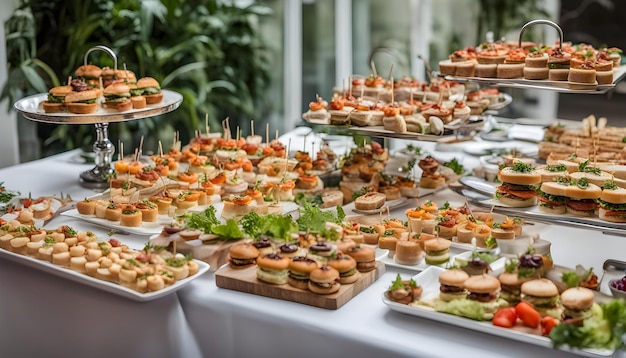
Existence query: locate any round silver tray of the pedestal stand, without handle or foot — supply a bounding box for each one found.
[14,90,183,124]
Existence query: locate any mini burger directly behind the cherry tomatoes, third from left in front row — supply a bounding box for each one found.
[521,278,563,319]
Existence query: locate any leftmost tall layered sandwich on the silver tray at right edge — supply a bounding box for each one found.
[495,161,541,208]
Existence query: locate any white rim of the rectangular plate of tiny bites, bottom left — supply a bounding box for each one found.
[0,249,210,302]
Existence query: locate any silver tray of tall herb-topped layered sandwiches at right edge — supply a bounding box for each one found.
[459,161,626,235]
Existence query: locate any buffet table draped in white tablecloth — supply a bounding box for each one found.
[0,133,626,358]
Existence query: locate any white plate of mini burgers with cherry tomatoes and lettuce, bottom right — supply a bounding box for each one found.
[382,267,625,357]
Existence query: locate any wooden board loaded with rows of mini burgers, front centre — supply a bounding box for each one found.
[215,243,385,309]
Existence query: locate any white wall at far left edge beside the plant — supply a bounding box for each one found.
[0,0,19,168]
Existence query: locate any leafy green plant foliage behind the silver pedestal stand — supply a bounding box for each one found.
[0,0,270,154]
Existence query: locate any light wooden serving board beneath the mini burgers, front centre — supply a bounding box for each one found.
[215,261,385,310]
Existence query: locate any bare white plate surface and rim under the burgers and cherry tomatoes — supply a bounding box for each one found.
[382,266,614,357]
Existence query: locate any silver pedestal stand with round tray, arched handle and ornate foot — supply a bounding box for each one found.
[14,45,183,189]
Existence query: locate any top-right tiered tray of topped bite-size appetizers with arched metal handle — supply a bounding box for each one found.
[439,20,626,94]
